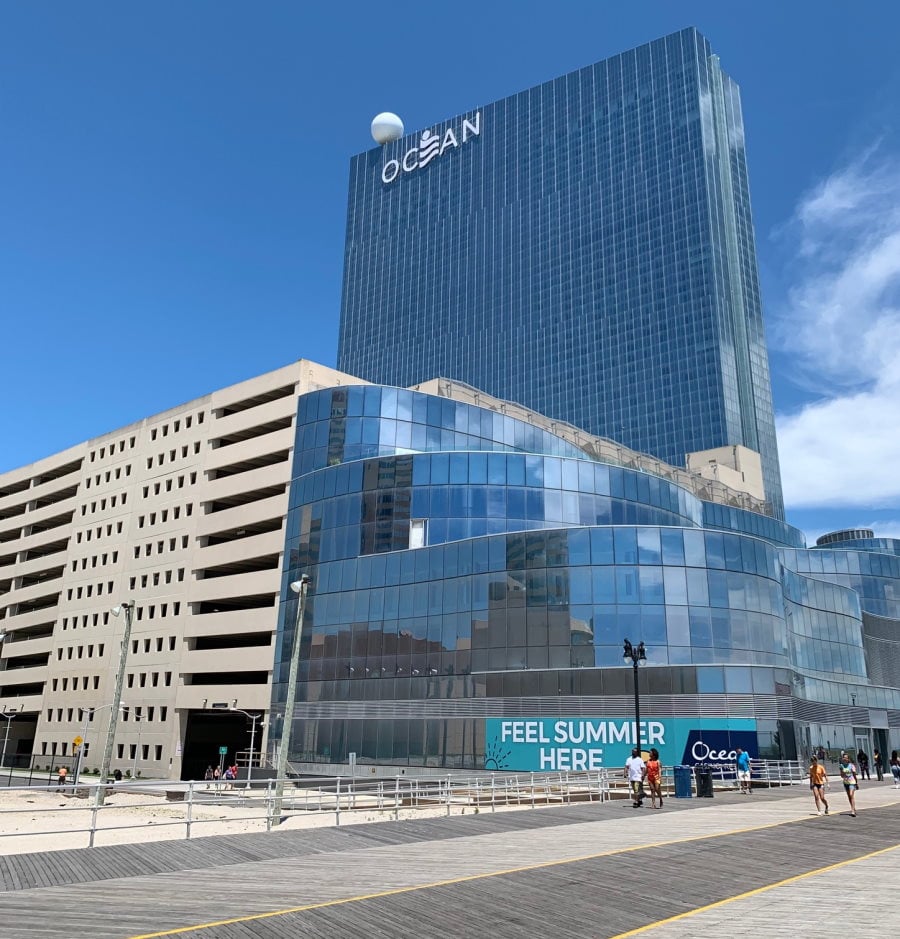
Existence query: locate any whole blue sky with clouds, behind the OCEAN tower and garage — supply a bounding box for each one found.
[0,0,900,537]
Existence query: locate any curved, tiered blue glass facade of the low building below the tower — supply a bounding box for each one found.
[273,386,900,768]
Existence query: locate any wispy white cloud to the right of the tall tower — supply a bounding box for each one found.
[776,151,900,510]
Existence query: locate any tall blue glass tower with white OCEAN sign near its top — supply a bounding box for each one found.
[338,28,783,518]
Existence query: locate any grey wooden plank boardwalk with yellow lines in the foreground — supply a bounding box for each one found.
[0,784,900,939]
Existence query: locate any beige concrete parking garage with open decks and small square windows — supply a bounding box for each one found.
[0,360,361,776]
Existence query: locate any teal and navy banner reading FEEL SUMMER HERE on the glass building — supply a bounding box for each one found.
[484,717,758,773]
